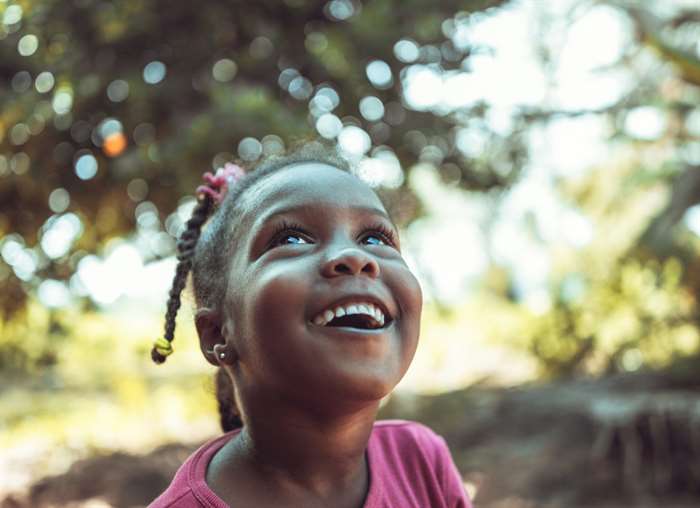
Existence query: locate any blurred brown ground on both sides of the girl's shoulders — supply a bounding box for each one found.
[5,373,700,508]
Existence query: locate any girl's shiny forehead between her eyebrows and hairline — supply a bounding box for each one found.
[241,162,384,220]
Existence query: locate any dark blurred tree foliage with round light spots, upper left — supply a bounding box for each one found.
[0,0,521,326]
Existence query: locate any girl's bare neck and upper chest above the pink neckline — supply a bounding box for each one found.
[207,401,379,507]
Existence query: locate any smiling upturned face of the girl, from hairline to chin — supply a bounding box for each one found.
[223,163,422,410]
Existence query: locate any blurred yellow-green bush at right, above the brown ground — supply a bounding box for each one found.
[529,258,700,376]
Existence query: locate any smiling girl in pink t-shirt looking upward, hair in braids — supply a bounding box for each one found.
[151,144,470,508]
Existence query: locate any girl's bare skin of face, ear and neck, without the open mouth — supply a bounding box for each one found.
[196,163,422,508]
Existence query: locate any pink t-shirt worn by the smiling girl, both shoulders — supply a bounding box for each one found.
[150,420,471,508]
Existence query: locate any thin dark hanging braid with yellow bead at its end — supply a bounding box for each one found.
[151,195,214,363]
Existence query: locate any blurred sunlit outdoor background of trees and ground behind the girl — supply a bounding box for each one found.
[0,0,700,508]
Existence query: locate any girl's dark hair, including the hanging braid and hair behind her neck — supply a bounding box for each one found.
[151,141,350,432]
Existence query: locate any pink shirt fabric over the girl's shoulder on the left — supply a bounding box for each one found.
[148,433,234,508]
